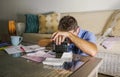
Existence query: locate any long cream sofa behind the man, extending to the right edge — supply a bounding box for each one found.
[17,10,120,76]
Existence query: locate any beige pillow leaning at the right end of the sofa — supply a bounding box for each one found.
[103,10,120,36]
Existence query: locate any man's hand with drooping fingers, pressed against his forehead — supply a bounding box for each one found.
[52,31,69,45]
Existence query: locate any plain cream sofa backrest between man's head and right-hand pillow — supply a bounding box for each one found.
[62,10,114,34]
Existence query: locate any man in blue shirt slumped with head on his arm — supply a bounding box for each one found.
[52,16,97,56]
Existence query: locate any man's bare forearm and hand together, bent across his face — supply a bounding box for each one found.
[52,32,97,56]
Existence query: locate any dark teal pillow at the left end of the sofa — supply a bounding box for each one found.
[25,14,39,33]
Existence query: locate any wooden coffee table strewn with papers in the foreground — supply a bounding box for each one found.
[0,51,102,77]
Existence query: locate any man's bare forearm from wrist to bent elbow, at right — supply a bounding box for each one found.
[68,32,97,56]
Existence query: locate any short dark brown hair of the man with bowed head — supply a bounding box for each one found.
[58,16,78,31]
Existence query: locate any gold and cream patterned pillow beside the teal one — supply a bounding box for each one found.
[39,12,60,34]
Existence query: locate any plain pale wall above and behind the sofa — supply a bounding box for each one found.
[0,0,120,41]
